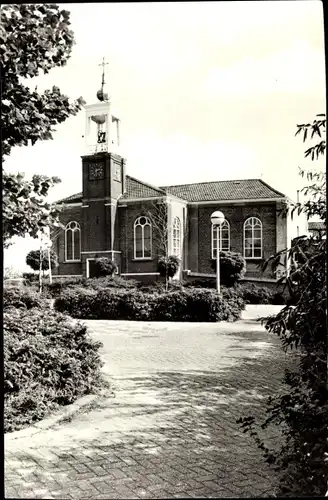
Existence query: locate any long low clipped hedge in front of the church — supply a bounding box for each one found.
[54,287,245,322]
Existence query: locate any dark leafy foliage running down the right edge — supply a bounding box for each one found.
[239,115,328,497]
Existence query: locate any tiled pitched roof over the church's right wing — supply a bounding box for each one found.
[162,179,285,202]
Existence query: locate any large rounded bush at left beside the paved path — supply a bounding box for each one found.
[3,309,103,432]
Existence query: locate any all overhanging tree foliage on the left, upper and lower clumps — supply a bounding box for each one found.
[0,4,84,246]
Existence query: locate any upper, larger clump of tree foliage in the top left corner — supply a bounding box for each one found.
[0,4,83,155]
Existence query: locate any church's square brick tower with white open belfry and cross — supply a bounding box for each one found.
[81,58,125,276]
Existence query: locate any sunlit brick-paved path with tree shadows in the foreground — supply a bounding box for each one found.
[5,306,292,500]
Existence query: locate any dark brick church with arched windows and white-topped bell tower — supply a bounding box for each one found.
[53,66,307,282]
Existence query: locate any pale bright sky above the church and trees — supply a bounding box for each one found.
[5,0,326,270]
